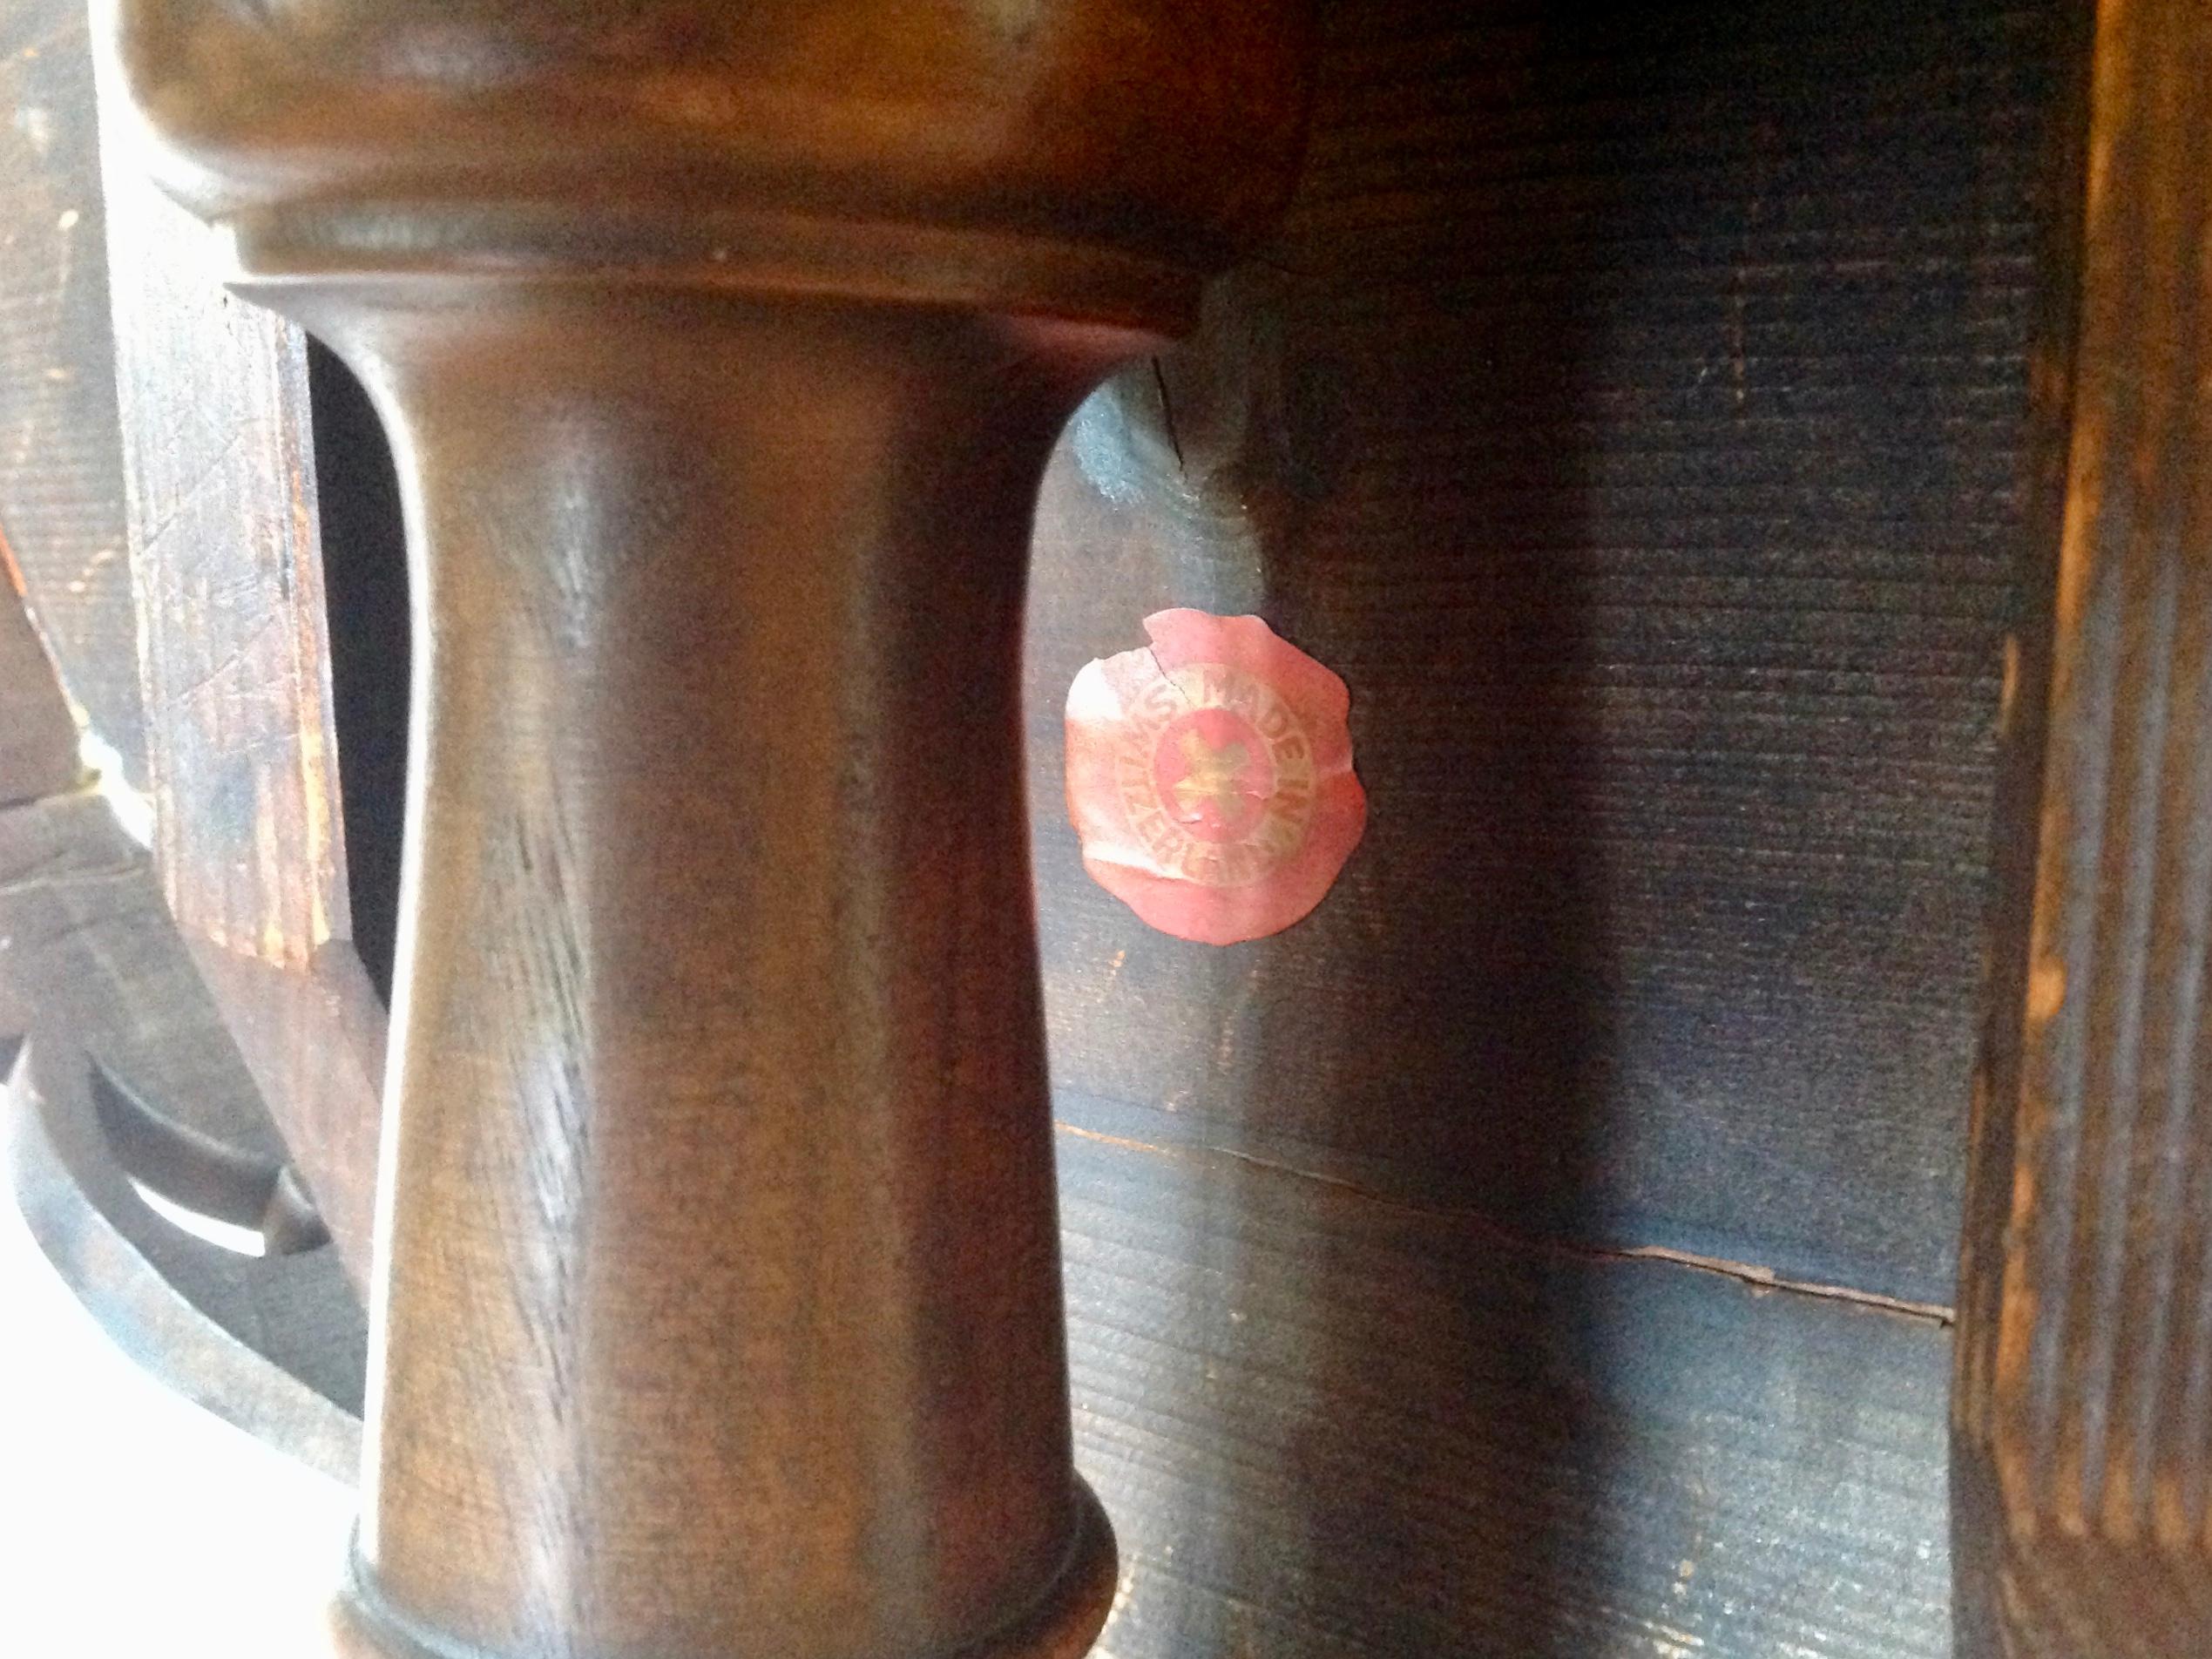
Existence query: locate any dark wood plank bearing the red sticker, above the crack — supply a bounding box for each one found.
[1029,0,2066,1303]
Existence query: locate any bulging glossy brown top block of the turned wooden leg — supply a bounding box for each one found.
[106,0,1308,331]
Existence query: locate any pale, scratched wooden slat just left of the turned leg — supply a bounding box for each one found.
[89,48,389,1281]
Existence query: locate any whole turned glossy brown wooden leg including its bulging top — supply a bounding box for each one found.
[102,0,1305,1659]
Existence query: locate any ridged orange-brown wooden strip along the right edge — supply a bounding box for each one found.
[1955,0,2212,1659]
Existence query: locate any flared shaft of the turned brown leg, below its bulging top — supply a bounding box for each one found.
[325,295,1120,1655]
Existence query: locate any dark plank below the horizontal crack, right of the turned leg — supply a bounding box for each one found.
[1059,1126,1951,1659]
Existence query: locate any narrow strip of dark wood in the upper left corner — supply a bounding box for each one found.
[0,0,146,788]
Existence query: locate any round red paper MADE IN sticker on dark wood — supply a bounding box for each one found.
[1068,611,1367,945]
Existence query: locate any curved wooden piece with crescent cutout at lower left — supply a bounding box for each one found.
[0,792,365,1469]
